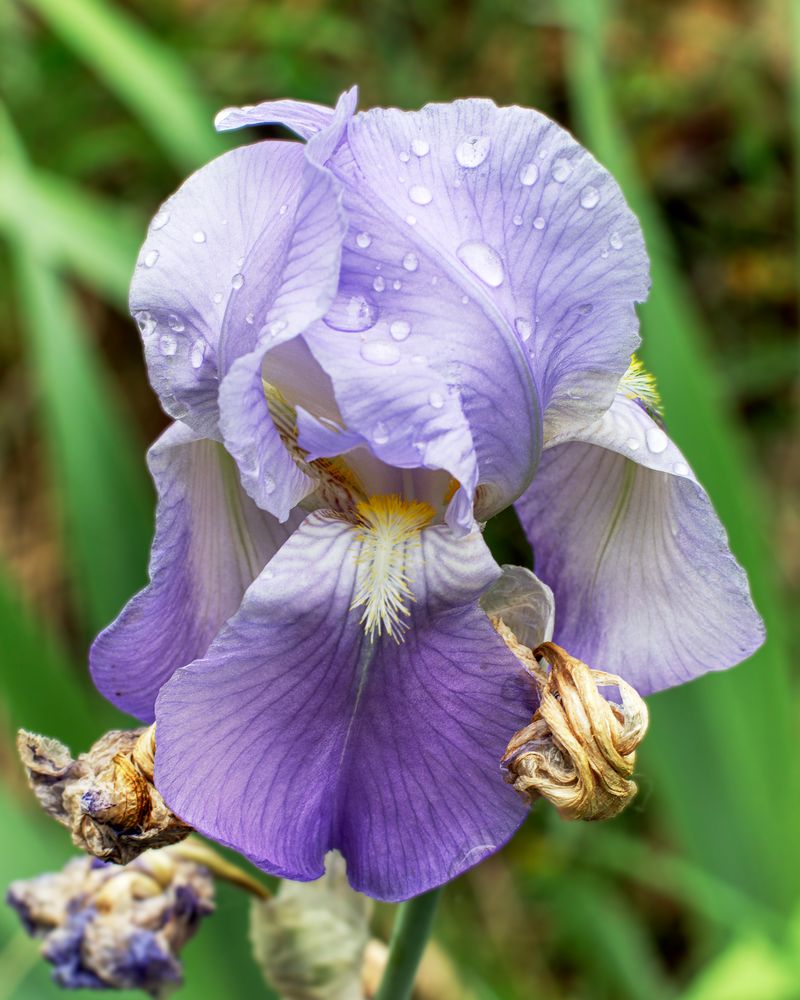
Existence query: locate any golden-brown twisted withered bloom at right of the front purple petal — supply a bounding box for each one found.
[495,640,648,820]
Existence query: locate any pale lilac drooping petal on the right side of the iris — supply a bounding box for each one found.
[517,395,764,694]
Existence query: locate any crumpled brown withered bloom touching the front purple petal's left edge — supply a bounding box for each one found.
[17,726,191,864]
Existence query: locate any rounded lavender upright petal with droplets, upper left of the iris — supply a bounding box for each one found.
[130,142,343,446]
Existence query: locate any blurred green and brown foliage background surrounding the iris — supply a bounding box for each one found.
[0,0,800,1000]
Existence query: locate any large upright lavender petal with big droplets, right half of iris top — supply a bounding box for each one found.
[296,100,648,516]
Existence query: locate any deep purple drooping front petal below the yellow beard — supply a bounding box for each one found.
[156,513,530,900]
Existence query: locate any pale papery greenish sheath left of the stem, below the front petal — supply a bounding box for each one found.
[250,855,371,1000]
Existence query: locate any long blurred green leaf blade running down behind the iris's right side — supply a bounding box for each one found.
[568,0,800,906]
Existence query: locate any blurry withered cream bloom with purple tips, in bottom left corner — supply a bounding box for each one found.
[7,848,214,997]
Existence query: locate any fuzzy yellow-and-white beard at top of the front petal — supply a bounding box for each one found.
[351,496,435,642]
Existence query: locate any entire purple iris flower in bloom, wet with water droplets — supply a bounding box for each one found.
[91,91,763,900]
